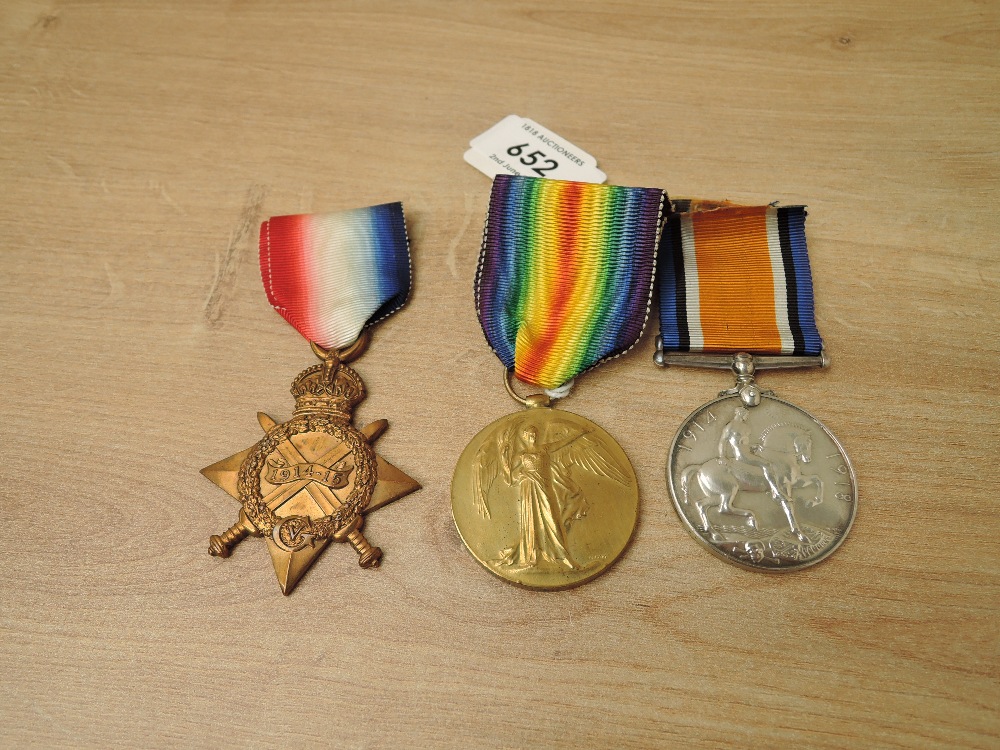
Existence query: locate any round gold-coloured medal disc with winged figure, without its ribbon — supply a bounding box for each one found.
[451,407,639,590]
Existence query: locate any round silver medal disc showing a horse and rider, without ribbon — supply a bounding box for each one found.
[667,395,858,571]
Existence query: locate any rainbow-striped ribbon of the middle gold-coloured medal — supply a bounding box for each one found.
[476,175,666,388]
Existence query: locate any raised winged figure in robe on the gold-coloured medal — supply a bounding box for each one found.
[473,418,628,570]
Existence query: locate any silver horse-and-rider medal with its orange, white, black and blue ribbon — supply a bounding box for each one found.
[656,206,857,571]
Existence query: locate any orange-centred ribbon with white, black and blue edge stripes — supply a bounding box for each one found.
[659,206,823,354]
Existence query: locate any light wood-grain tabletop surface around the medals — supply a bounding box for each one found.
[0,0,1000,748]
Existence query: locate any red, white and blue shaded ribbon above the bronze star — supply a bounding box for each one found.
[260,203,410,349]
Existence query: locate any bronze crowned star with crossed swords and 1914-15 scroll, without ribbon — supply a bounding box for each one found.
[202,331,420,594]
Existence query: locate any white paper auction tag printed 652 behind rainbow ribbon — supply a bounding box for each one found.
[465,115,607,183]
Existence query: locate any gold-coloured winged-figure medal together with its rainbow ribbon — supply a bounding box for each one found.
[451,175,665,590]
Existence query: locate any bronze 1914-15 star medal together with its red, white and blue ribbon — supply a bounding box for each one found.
[202,203,420,594]
